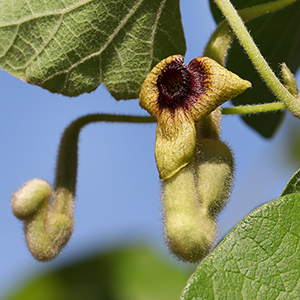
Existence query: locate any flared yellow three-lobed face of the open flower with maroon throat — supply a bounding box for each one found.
[139,55,251,179]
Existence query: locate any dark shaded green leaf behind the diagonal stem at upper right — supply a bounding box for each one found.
[210,0,300,138]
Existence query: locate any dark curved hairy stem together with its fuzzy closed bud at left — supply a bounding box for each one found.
[11,114,155,261]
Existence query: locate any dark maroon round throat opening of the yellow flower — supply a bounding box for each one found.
[157,62,191,110]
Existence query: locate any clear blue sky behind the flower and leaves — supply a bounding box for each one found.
[0,0,300,298]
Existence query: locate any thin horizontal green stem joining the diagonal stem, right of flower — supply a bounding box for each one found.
[222,102,286,115]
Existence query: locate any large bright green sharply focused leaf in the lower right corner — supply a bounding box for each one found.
[181,171,300,300]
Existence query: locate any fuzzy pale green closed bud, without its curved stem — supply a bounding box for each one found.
[11,179,74,261]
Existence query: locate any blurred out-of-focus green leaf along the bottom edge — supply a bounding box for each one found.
[6,246,190,300]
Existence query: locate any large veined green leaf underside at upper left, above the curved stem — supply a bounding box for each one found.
[0,0,185,99]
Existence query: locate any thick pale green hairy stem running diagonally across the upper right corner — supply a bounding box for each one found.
[215,0,300,118]
